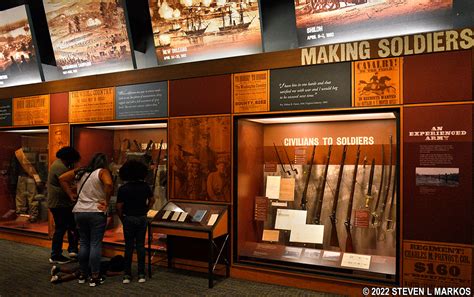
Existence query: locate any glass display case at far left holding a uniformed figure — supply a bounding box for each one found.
[0,128,48,234]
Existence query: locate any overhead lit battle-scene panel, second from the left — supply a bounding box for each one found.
[43,0,133,78]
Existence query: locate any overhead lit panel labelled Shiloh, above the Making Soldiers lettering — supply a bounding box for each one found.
[295,0,460,47]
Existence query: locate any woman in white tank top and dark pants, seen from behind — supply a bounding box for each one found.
[59,153,113,287]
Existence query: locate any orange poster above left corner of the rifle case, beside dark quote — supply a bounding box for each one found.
[232,71,270,113]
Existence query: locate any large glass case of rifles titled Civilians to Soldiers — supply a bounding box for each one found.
[234,109,399,283]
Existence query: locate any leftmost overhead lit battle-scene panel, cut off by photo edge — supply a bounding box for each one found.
[0,5,41,88]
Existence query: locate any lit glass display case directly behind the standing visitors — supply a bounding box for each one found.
[72,122,168,249]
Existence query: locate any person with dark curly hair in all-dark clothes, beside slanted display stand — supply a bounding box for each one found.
[117,160,155,284]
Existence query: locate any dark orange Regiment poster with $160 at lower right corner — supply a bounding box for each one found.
[403,240,473,288]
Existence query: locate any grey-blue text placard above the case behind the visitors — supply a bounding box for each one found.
[115,81,168,120]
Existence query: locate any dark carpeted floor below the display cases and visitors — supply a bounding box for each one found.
[0,240,342,297]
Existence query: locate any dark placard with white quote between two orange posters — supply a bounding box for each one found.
[270,63,351,111]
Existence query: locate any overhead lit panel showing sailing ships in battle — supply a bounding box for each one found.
[148,0,262,65]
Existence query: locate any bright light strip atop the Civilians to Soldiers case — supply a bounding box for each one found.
[249,112,396,124]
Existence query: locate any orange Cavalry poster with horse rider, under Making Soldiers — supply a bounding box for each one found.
[352,58,403,106]
